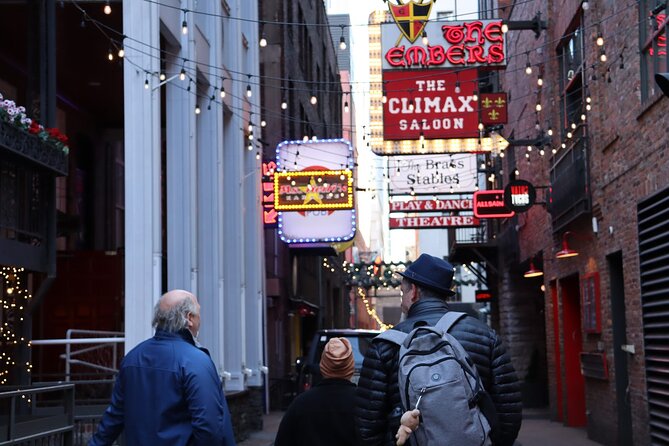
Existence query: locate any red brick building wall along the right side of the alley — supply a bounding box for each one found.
[498,0,669,445]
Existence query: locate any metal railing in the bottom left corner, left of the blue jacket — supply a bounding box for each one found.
[0,384,74,446]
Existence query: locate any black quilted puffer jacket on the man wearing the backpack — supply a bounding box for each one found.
[355,297,522,446]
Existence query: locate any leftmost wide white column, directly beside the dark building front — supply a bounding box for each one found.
[123,0,162,352]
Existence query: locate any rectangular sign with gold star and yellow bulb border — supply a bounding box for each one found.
[274,169,353,211]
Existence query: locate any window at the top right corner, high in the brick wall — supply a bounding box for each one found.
[639,0,668,102]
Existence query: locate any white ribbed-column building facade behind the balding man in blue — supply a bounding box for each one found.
[123,0,266,391]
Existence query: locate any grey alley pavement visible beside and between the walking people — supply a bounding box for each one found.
[238,409,599,446]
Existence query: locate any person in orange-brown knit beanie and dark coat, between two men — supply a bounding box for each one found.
[274,338,358,446]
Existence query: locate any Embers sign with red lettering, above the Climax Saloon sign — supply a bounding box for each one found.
[381,19,506,69]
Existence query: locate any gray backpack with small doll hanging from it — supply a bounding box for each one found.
[376,311,496,446]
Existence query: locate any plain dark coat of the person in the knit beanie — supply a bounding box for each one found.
[274,378,356,446]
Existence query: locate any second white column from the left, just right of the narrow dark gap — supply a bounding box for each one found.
[165,3,199,298]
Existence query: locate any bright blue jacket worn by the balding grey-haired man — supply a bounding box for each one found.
[88,330,235,446]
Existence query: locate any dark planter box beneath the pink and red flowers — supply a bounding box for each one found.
[0,121,68,176]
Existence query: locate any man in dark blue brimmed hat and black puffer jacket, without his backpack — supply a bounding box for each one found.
[355,254,522,446]
